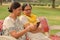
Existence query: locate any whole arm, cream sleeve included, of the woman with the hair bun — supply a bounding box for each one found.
[3,20,30,38]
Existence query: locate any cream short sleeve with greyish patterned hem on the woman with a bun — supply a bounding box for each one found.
[3,20,16,34]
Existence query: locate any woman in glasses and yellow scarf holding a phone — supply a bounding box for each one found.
[19,3,50,40]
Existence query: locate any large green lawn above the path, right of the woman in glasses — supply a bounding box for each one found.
[32,7,60,25]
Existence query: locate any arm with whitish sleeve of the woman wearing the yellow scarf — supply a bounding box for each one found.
[20,16,37,32]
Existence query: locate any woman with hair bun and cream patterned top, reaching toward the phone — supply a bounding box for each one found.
[3,2,35,40]
